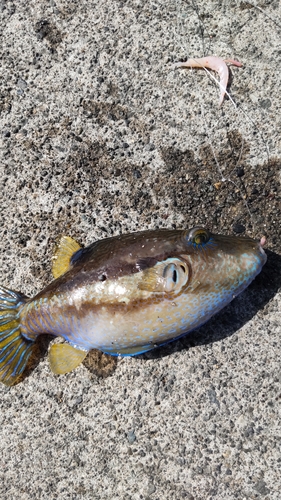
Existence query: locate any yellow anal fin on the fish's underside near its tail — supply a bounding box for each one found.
[49,344,88,375]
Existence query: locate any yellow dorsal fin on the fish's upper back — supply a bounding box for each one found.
[52,235,81,278]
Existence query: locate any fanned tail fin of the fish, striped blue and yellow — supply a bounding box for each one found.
[0,286,34,386]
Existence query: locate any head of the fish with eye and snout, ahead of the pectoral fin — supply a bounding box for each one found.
[174,227,267,310]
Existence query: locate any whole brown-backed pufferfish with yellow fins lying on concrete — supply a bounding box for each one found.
[0,227,266,385]
